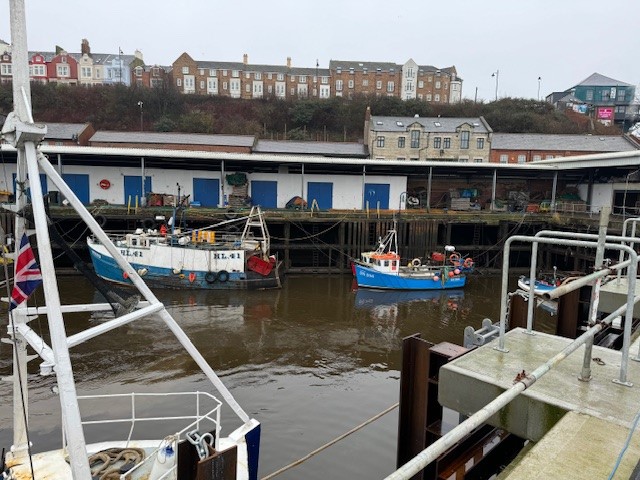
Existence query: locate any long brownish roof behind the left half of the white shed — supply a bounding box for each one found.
[89,131,255,148]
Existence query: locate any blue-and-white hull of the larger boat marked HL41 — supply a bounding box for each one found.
[88,240,281,290]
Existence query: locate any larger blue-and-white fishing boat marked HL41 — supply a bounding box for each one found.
[87,207,281,290]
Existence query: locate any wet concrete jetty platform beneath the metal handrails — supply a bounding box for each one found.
[438,328,640,479]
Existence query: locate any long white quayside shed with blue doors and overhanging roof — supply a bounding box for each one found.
[0,128,640,213]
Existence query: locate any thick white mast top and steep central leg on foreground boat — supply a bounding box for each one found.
[3,0,91,479]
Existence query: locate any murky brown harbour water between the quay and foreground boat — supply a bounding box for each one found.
[0,275,540,480]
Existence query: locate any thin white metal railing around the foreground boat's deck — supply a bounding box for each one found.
[62,391,222,456]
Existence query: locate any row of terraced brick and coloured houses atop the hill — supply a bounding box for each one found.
[0,39,462,104]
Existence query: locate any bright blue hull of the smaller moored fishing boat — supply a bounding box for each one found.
[354,263,467,290]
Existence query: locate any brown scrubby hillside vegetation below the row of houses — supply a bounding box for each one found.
[0,83,621,141]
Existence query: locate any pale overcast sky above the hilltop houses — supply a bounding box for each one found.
[0,0,640,101]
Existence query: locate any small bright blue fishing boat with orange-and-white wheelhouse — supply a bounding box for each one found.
[353,229,473,290]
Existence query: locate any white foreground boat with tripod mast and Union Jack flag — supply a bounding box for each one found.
[0,0,261,480]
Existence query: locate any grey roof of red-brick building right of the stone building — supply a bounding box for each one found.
[491,133,638,153]
